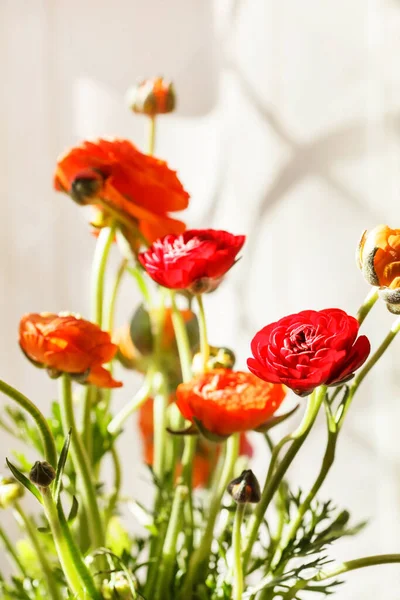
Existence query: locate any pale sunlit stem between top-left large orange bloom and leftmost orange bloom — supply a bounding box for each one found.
[91,224,115,327]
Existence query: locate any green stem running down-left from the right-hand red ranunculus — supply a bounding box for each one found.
[243,386,326,573]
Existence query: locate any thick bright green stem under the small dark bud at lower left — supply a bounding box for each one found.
[42,488,101,600]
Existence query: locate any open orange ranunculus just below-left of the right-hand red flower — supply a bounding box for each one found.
[176,369,285,437]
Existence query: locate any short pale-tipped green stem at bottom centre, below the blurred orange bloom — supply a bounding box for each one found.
[154,485,188,600]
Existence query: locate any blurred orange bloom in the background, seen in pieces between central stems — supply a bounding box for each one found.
[139,398,253,488]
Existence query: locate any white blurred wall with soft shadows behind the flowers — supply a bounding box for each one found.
[0,0,400,600]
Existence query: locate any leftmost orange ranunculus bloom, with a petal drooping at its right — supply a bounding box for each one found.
[19,313,122,388]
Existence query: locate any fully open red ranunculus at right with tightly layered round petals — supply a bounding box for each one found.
[247,308,370,396]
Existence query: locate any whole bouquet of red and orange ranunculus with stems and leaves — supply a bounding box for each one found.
[0,78,400,600]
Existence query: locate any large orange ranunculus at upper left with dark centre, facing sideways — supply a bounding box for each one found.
[54,139,189,243]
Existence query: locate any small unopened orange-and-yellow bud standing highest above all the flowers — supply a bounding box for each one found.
[127,77,176,117]
